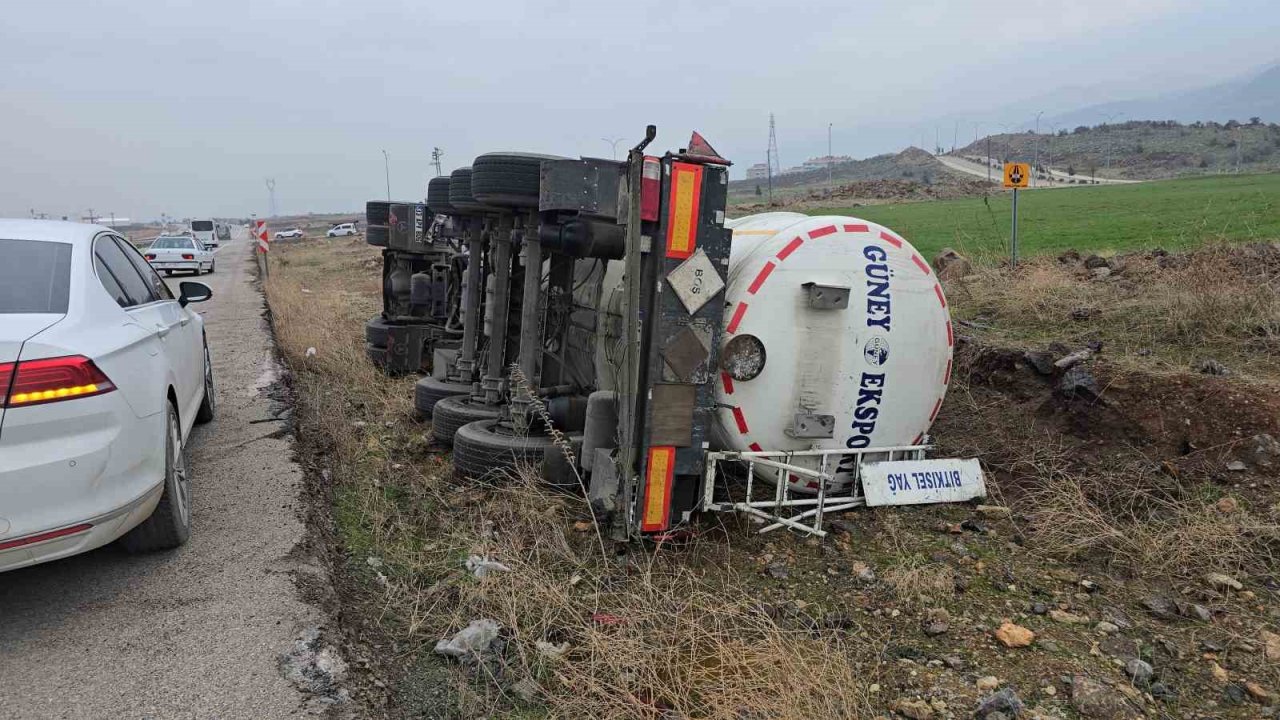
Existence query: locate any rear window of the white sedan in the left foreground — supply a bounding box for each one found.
[0,238,72,314]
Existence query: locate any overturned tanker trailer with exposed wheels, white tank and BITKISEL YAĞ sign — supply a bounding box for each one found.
[370,127,984,538]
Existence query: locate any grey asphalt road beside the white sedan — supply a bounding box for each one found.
[0,229,321,720]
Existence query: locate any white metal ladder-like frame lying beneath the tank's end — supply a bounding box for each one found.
[699,445,932,537]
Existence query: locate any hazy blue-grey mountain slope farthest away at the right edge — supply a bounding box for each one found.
[1048,64,1280,127]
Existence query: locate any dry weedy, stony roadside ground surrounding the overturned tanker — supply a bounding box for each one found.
[268,233,1280,719]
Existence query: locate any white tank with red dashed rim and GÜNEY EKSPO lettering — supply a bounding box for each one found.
[596,213,954,492]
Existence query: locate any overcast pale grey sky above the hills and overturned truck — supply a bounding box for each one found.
[0,0,1280,218]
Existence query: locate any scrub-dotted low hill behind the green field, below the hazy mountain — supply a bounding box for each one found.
[955,117,1280,179]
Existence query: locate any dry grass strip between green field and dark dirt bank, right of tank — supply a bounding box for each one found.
[948,243,1280,379]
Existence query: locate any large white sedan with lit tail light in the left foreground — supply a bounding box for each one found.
[0,220,214,571]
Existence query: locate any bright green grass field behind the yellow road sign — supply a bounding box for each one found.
[809,173,1280,259]
